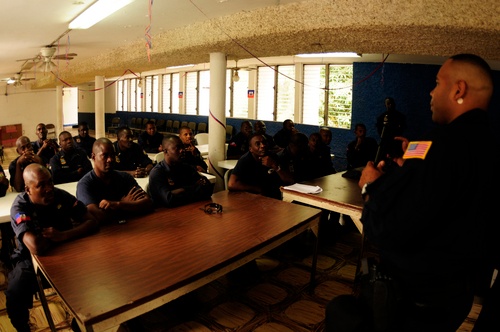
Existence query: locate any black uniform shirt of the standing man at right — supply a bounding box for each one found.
[361,110,499,303]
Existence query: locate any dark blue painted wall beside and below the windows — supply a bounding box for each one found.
[83,62,500,171]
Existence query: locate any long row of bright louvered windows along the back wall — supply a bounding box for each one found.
[117,64,353,129]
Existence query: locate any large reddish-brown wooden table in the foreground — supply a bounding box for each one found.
[33,191,321,331]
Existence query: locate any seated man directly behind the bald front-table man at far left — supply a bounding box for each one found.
[9,136,45,192]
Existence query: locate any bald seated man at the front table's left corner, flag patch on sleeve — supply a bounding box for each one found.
[5,164,98,331]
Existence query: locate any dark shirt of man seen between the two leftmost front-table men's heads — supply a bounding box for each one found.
[50,148,92,184]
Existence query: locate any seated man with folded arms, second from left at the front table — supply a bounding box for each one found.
[76,138,153,223]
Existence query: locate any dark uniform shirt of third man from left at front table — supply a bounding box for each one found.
[148,160,213,207]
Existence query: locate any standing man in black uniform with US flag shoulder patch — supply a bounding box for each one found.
[346,54,500,332]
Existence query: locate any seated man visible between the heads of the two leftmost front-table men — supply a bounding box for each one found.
[50,131,92,184]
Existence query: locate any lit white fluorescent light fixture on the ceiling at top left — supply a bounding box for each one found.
[68,0,134,30]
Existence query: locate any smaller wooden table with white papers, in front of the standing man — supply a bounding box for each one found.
[281,172,364,233]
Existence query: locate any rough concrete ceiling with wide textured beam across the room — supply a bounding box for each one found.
[0,0,500,88]
